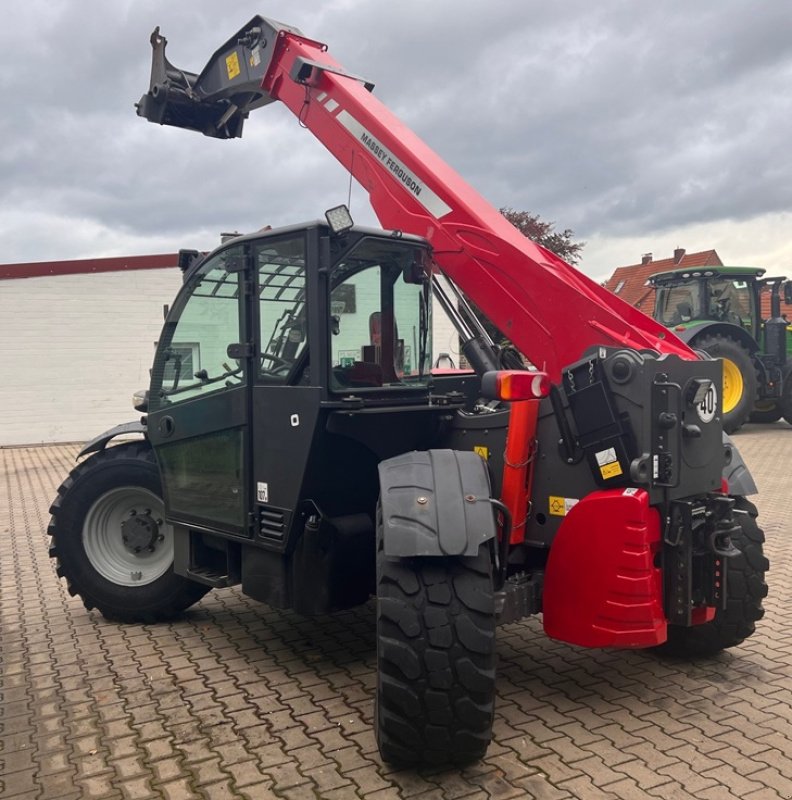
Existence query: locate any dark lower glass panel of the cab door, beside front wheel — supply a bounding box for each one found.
[158,428,245,529]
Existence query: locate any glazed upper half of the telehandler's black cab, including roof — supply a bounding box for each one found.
[149,222,431,411]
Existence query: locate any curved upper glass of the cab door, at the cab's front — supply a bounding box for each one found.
[150,247,244,411]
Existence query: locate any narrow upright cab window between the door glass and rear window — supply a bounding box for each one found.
[256,236,308,383]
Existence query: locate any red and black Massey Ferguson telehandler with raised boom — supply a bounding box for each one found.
[49,16,768,764]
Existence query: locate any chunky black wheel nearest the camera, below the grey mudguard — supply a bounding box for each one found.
[376,510,495,766]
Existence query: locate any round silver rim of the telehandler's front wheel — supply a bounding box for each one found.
[82,486,173,586]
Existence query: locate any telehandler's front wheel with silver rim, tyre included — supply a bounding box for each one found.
[48,442,209,622]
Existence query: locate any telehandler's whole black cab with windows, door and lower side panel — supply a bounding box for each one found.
[140,221,441,549]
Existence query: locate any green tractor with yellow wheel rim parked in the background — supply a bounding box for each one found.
[649,267,792,433]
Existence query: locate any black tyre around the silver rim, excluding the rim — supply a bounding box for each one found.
[47,440,209,623]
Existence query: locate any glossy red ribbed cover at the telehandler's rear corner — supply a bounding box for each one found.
[542,489,667,647]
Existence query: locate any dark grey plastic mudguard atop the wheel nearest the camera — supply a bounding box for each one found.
[379,450,496,558]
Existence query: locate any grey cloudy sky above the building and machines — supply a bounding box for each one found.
[0,0,792,278]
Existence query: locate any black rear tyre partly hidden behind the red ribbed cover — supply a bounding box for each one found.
[656,497,770,658]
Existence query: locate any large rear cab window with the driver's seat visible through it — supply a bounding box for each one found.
[329,237,431,391]
